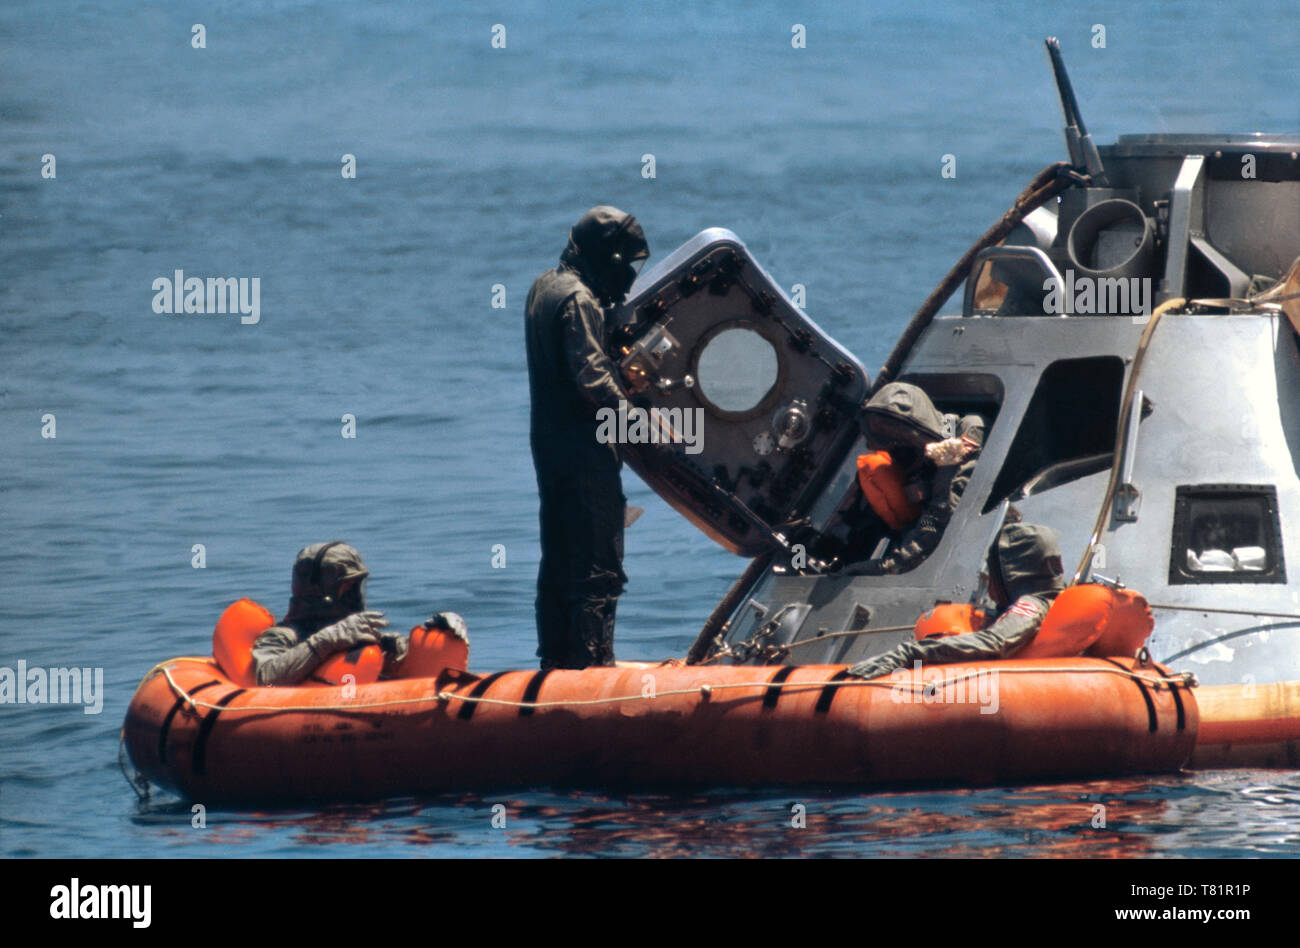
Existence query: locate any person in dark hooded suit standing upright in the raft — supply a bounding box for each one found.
[525,204,650,668]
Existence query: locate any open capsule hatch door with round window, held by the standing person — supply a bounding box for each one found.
[606,228,868,557]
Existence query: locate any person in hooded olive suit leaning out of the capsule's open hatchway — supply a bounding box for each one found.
[844,382,985,576]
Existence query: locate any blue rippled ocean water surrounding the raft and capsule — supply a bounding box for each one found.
[0,0,1300,857]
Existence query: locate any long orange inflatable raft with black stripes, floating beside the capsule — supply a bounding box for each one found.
[124,603,1201,802]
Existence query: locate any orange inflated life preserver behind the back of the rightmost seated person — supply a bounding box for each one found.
[1015,583,1154,658]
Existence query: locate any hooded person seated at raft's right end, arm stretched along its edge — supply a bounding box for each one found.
[849,523,1065,679]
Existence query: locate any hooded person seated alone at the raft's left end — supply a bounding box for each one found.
[252,540,468,685]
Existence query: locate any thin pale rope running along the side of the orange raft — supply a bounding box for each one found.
[146,658,1197,714]
